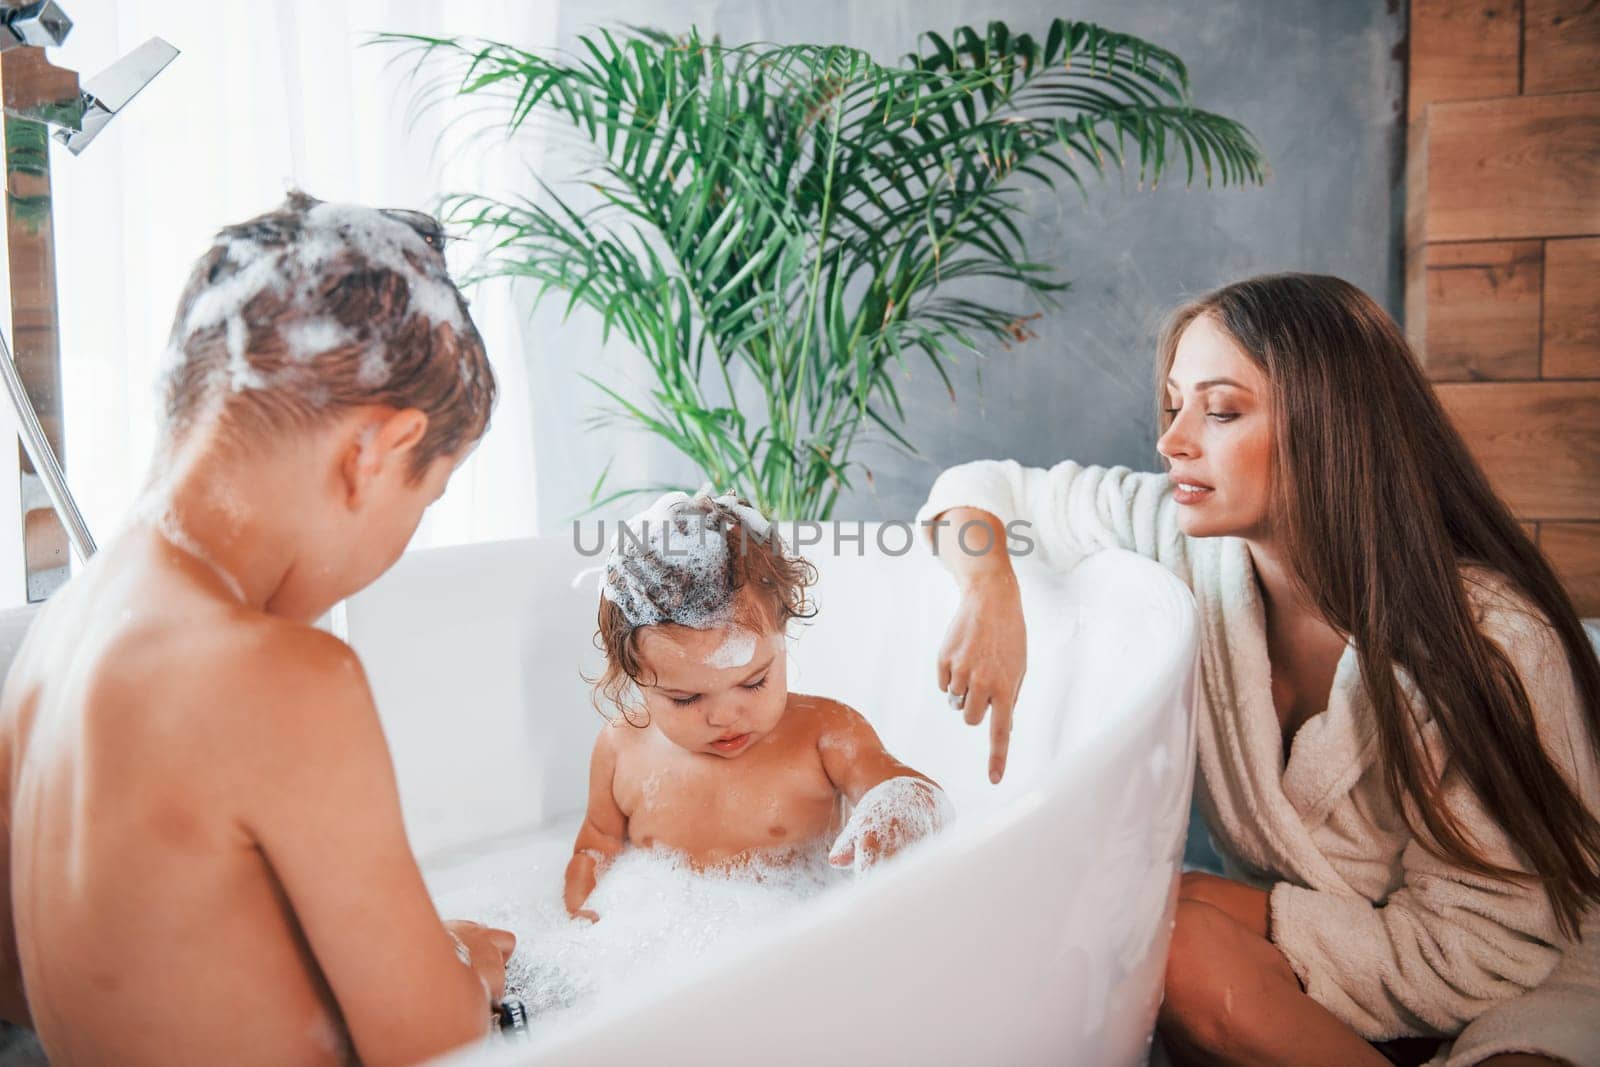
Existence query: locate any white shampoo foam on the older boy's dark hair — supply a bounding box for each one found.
[183,203,475,392]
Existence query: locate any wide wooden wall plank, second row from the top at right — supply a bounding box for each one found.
[1406,93,1600,242]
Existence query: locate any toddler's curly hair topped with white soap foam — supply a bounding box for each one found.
[595,490,816,721]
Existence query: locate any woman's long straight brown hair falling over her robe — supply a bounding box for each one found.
[1157,274,1600,936]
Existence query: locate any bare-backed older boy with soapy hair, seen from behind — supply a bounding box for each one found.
[0,194,514,1067]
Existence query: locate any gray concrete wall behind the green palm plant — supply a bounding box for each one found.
[538,0,1405,528]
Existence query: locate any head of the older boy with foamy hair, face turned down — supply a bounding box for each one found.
[165,192,494,613]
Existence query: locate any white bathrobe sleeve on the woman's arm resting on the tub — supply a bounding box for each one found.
[917,459,1189,582]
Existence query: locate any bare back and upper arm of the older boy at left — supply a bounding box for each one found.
[0,531,486,1064]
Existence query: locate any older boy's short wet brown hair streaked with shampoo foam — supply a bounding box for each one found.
[165,192,494,480]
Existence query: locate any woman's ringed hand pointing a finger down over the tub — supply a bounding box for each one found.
[939,566,1027,782]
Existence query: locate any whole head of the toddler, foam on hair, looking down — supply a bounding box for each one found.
[597,493,816,758]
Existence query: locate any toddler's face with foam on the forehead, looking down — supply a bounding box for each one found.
[638,607,789,760]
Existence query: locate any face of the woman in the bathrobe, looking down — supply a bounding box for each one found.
[1155,315,1272,541]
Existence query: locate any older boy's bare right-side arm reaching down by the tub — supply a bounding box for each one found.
[236,627,515,1064]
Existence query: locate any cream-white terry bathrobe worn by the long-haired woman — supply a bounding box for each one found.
[917,461,1600,1067]
